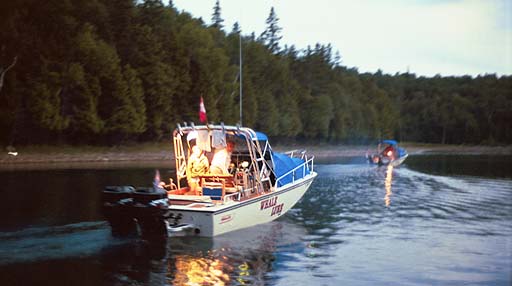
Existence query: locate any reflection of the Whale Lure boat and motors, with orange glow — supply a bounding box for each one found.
[98,222,303,285]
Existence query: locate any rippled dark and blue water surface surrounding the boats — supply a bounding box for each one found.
[0,155,512,286]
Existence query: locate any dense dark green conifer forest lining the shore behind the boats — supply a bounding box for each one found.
[0,0,512,146]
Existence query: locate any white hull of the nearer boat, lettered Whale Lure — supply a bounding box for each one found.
[167,172,317,237]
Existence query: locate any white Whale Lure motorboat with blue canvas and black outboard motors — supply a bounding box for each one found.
[103,125,317,237]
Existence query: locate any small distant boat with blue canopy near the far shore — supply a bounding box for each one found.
[366,139,409,167]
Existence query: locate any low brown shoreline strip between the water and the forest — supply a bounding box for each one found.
[0,142,512,166]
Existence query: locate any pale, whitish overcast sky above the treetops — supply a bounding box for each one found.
[173,0,512,77]
